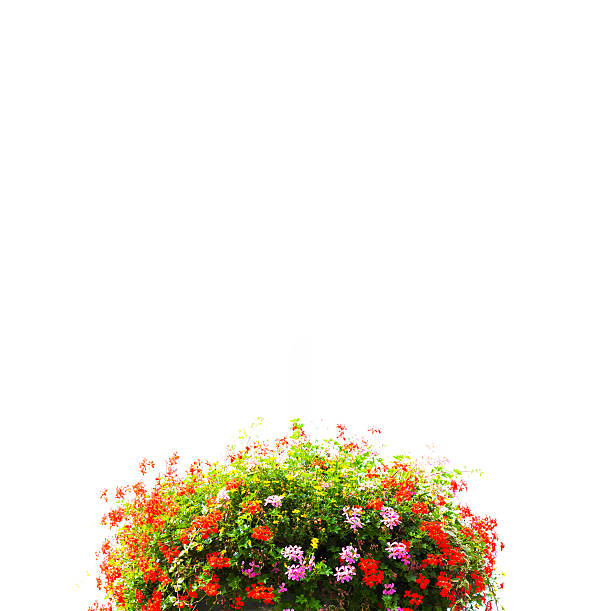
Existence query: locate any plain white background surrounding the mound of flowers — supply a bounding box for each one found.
[0,0,612,611]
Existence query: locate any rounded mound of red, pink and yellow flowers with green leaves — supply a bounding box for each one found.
[89,420,503,611]
